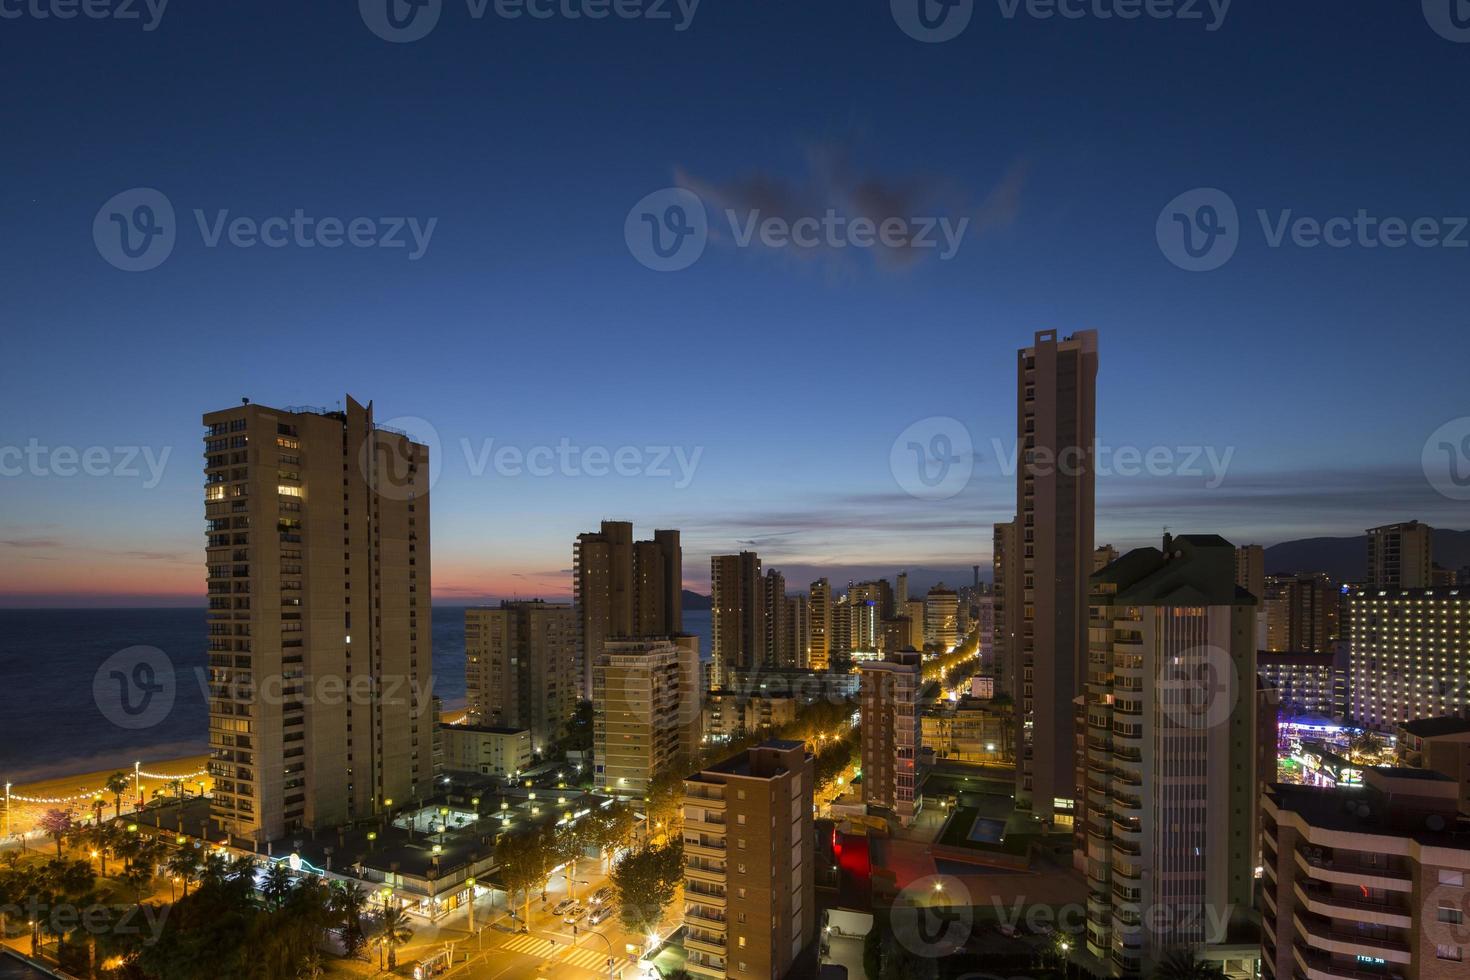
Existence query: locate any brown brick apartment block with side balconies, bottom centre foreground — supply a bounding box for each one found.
[684,741,817,980]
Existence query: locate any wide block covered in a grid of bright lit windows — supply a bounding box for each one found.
[1348,589,1470,732]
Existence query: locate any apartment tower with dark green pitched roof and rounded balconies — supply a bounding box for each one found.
[1079,535,1258,977]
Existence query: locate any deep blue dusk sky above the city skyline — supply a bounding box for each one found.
[0,0,1470,602]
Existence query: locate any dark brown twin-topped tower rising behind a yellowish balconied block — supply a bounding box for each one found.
[572,520,684,696]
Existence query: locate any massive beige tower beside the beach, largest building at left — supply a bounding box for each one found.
[204,398,434,843]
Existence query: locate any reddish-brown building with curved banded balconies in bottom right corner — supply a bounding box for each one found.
[1260,768,1470,980]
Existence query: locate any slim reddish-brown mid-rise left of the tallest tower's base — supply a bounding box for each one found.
[858,651,923,827]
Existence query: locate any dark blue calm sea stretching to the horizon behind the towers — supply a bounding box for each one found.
[0,605,710,783]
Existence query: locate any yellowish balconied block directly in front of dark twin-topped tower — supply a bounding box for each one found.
[592,636,704,798]
